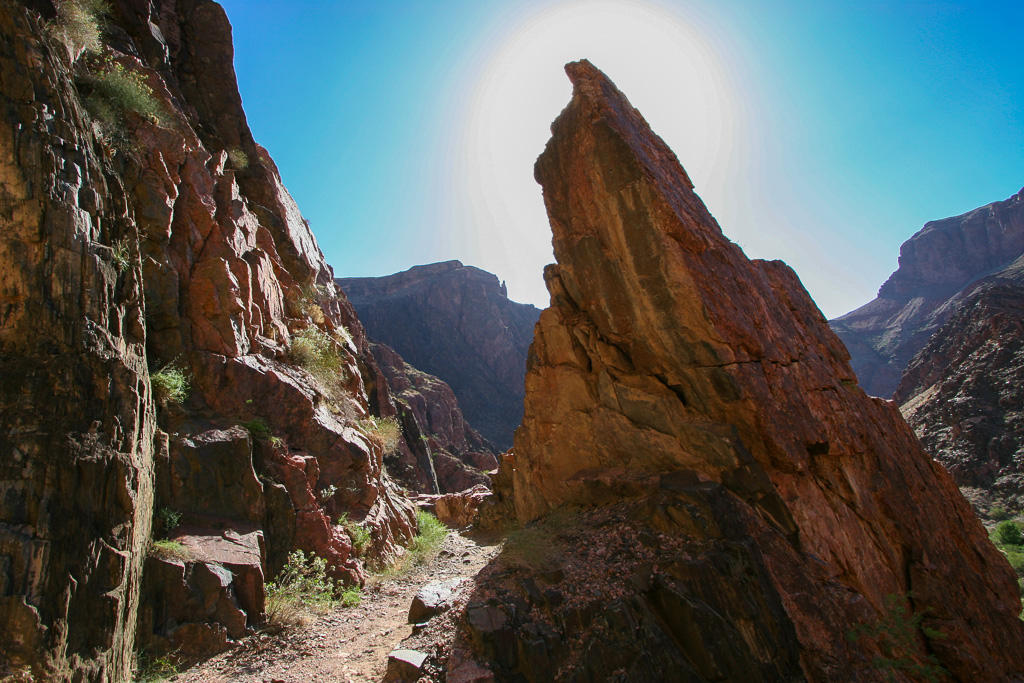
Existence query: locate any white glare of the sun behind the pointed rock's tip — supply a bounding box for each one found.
[450,0,742,304]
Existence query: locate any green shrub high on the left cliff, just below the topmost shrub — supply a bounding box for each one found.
[77,57,166,125]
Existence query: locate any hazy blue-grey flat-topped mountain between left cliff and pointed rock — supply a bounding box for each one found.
[337,261,540,449]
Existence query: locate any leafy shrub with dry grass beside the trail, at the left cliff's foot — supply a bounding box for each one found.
[266,550,359,632]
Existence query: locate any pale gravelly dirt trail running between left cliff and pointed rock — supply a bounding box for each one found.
[167,531,499,683]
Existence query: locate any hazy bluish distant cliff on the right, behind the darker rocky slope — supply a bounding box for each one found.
[829,190,1024,398]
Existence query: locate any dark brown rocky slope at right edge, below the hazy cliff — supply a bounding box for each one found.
[894,285,1024,509]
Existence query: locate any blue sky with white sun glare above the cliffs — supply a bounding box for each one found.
[222,0,1024,317]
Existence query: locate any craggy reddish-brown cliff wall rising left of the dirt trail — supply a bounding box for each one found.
[0,0,415,681]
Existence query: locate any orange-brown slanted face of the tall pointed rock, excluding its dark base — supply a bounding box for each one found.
[512,61,1024,681]
